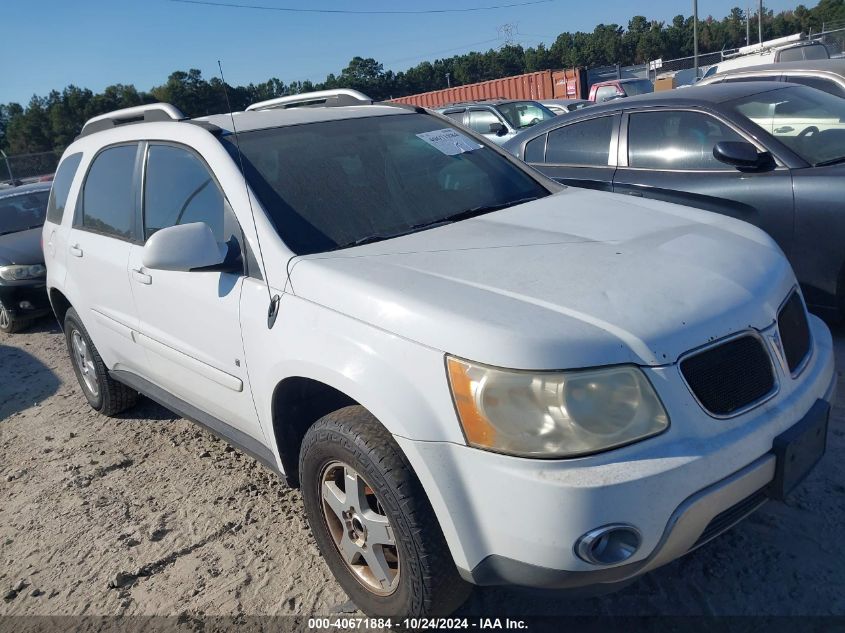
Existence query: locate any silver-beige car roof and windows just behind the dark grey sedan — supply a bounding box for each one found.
[697,59,845,97]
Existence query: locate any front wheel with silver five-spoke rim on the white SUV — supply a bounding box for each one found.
[299,406,471,618]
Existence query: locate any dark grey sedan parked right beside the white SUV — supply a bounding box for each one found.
[505,82,845,314]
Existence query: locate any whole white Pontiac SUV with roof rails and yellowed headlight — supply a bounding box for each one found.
[43,92,834,617]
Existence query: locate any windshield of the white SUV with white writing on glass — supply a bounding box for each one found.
[222,113,549,255]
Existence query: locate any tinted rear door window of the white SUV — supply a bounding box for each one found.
[82,145,137,239]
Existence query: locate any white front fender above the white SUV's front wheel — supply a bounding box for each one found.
[241,280,464,458]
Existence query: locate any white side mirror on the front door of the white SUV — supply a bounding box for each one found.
[141,222,229,271]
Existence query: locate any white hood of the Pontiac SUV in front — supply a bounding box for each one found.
[290,188,795,369]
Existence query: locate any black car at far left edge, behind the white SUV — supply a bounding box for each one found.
[0,183,50,333]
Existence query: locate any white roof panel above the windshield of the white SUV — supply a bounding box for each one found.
[192,104,414,133]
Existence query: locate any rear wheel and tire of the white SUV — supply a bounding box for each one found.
[65,308,138,416]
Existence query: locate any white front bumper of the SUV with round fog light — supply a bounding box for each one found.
[397,318,836,587]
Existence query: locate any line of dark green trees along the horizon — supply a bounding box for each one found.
[0,0,845,155]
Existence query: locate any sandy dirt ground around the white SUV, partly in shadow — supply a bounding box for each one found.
[0,319,845,617]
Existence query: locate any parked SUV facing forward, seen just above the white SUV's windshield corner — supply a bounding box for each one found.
[436,99,555,145]
